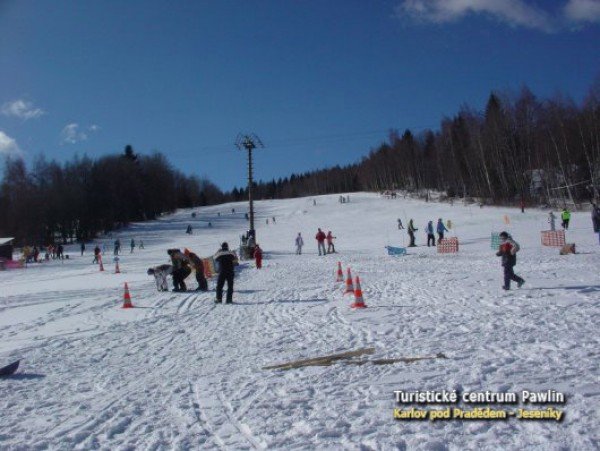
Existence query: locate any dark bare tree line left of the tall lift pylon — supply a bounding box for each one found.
[0,146,224,245]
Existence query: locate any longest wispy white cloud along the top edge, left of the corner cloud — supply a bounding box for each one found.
[396,0,556,32]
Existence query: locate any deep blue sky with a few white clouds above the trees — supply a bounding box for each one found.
[0,0,600,189]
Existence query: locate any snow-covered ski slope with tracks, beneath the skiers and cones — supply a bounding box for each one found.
[0,193,600,450]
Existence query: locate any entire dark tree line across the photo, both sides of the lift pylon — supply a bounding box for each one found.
[0,78,600,244]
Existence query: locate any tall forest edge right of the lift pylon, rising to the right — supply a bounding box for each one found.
[227,78,600,205]
